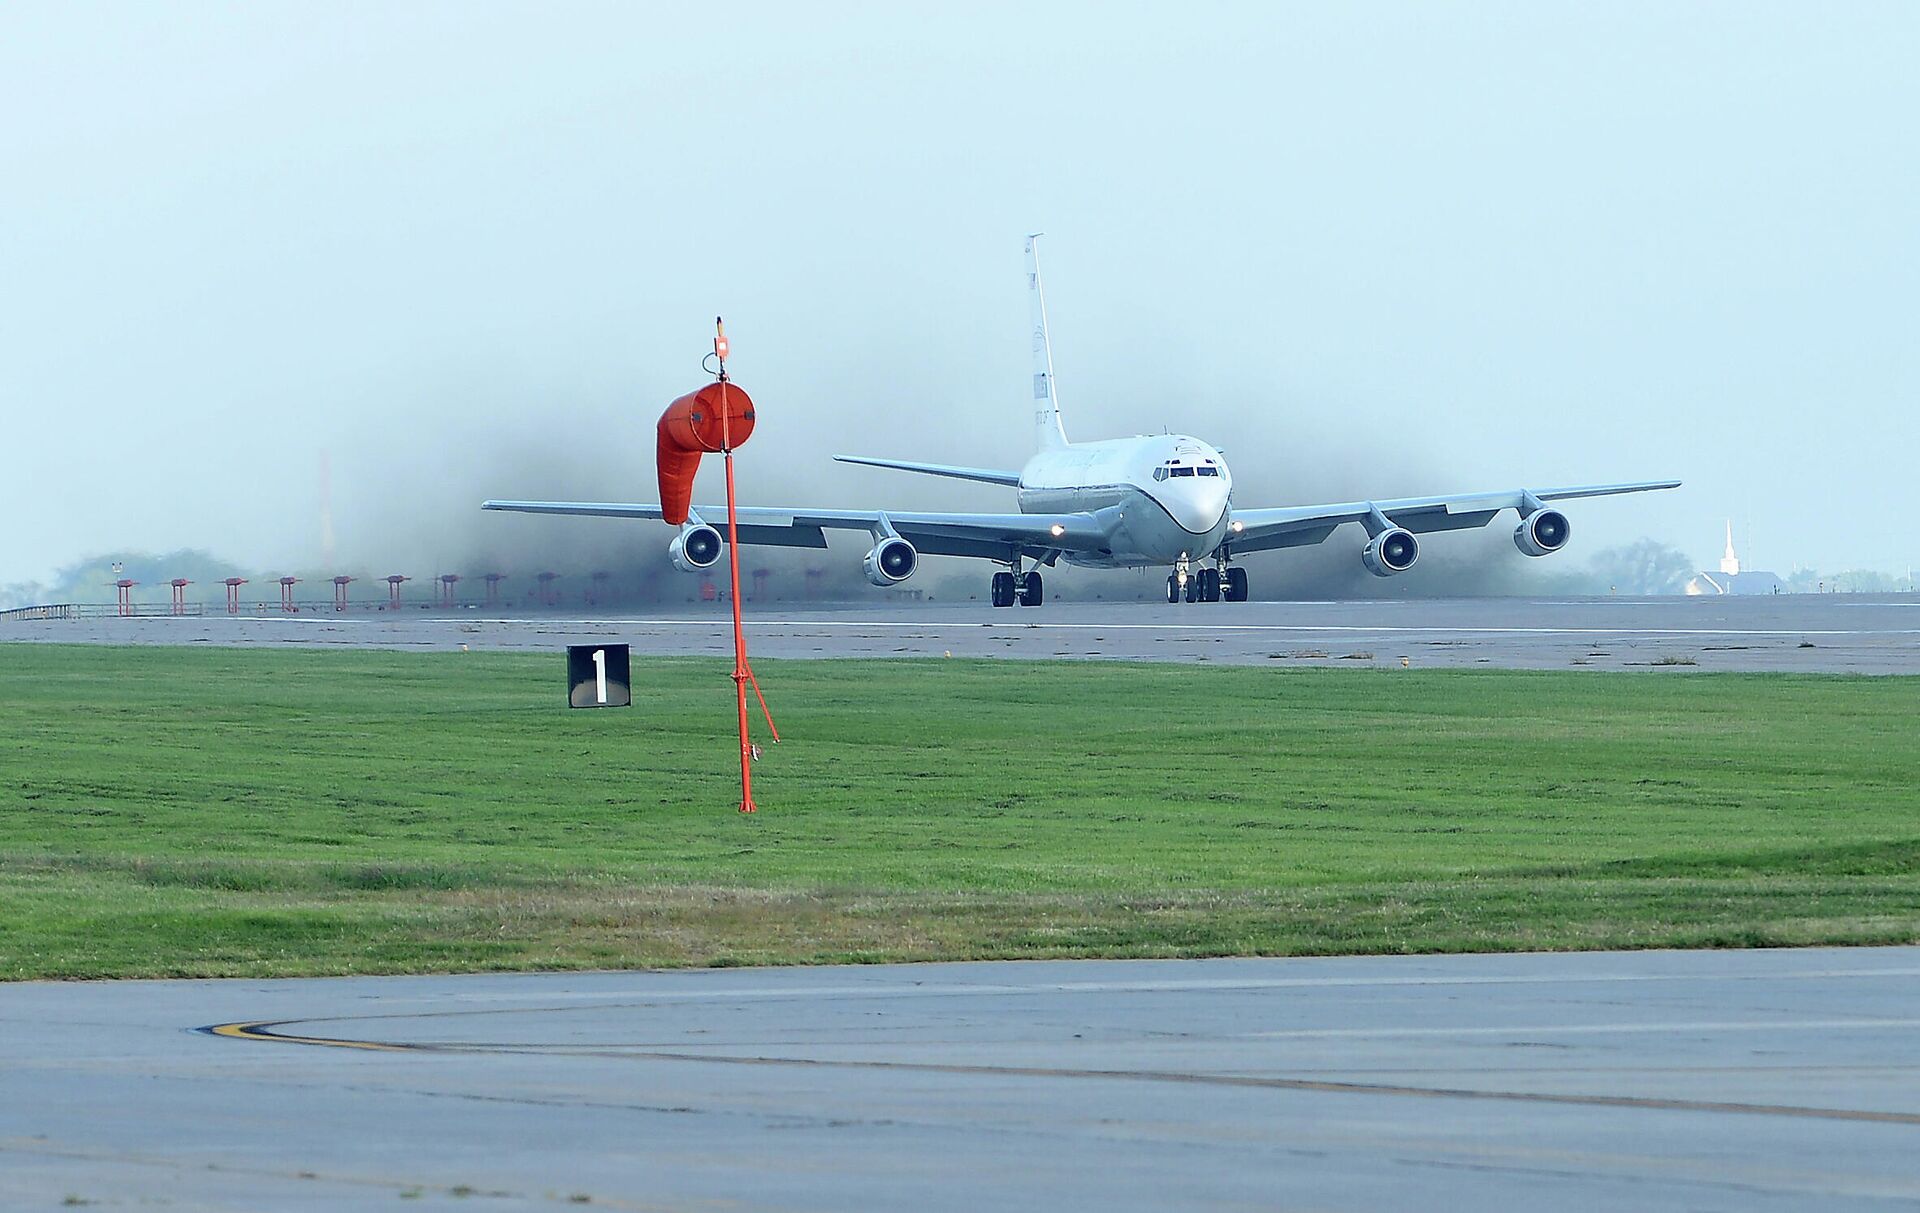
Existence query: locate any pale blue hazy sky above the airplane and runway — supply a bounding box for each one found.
[0,0,1920,582]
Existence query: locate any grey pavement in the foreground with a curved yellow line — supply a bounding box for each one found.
[0,948,1920,1211]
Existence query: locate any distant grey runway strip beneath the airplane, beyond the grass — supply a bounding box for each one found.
[0,595,1920,674]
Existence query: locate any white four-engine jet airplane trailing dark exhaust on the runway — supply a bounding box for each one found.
[482,236,1680,607]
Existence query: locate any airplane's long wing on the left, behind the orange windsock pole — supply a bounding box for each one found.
[480,501,1108,562]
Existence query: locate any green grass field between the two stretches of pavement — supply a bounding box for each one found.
[0,645,1920,979]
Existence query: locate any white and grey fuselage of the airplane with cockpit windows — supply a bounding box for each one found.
[1020,434,1233,568]
